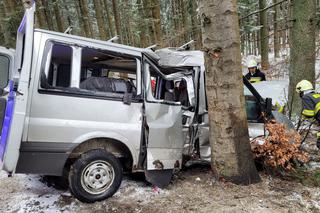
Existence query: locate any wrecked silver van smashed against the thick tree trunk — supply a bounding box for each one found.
[0,5,271,202]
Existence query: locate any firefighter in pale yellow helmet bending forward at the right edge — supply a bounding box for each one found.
[296,80,320,149]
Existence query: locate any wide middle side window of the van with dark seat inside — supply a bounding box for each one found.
[80,48,137,97]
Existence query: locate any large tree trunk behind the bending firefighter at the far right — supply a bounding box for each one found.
[289,0,316,114]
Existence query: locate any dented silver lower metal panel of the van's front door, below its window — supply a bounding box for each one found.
[145,102,184,170]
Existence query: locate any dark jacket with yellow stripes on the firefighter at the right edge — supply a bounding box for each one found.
[302,92,320,121]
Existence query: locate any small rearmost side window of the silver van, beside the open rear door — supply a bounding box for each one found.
[47,44,72,88]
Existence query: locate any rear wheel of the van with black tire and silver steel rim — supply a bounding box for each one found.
[69,149,122,203]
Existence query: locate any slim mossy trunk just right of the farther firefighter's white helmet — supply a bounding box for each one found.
[259,0,269,69]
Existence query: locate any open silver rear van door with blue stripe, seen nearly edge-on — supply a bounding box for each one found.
[0,4,35,173]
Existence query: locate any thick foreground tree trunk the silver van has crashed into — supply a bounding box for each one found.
[199,0,260,184]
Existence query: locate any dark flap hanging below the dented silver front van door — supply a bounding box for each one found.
[144,169,173,188]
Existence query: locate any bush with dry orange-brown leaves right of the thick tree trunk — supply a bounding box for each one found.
[251,120,309,171]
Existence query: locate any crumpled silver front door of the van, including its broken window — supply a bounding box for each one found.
[143,58,184,187]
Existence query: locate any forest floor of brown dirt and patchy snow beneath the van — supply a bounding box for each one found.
[0,136,320,213]
